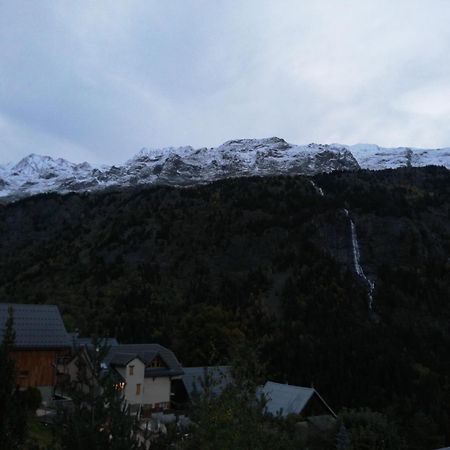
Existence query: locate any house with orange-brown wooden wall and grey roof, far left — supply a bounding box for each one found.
[0,303,71,401]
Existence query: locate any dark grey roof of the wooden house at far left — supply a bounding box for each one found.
[0,303,71,349]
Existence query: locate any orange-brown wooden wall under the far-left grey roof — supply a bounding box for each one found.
[11,349,69,387]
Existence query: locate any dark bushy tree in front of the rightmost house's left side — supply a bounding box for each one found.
[157,345,310,450]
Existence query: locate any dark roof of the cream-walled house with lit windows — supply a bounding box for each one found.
[103,344,184,378]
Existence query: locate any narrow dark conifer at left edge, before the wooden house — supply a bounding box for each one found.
[0,307,27,450]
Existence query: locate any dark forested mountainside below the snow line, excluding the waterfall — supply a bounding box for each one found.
[0,167,450,450]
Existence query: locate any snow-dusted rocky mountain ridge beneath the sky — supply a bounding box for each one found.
[0,137,450,200]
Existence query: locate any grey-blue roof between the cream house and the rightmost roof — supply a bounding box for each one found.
[182,366,232,397]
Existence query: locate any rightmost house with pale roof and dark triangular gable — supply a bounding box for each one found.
[260,381,337,418]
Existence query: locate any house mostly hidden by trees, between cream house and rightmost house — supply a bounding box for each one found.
[173,366,232,405]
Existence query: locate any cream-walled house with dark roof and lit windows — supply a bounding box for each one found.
[103,344,184,412]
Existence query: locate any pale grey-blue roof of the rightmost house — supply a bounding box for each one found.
[260,381,335,416]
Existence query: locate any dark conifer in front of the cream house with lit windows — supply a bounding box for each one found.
[58,342,146,450]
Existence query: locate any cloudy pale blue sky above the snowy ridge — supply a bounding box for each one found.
[0,0,450,164]
